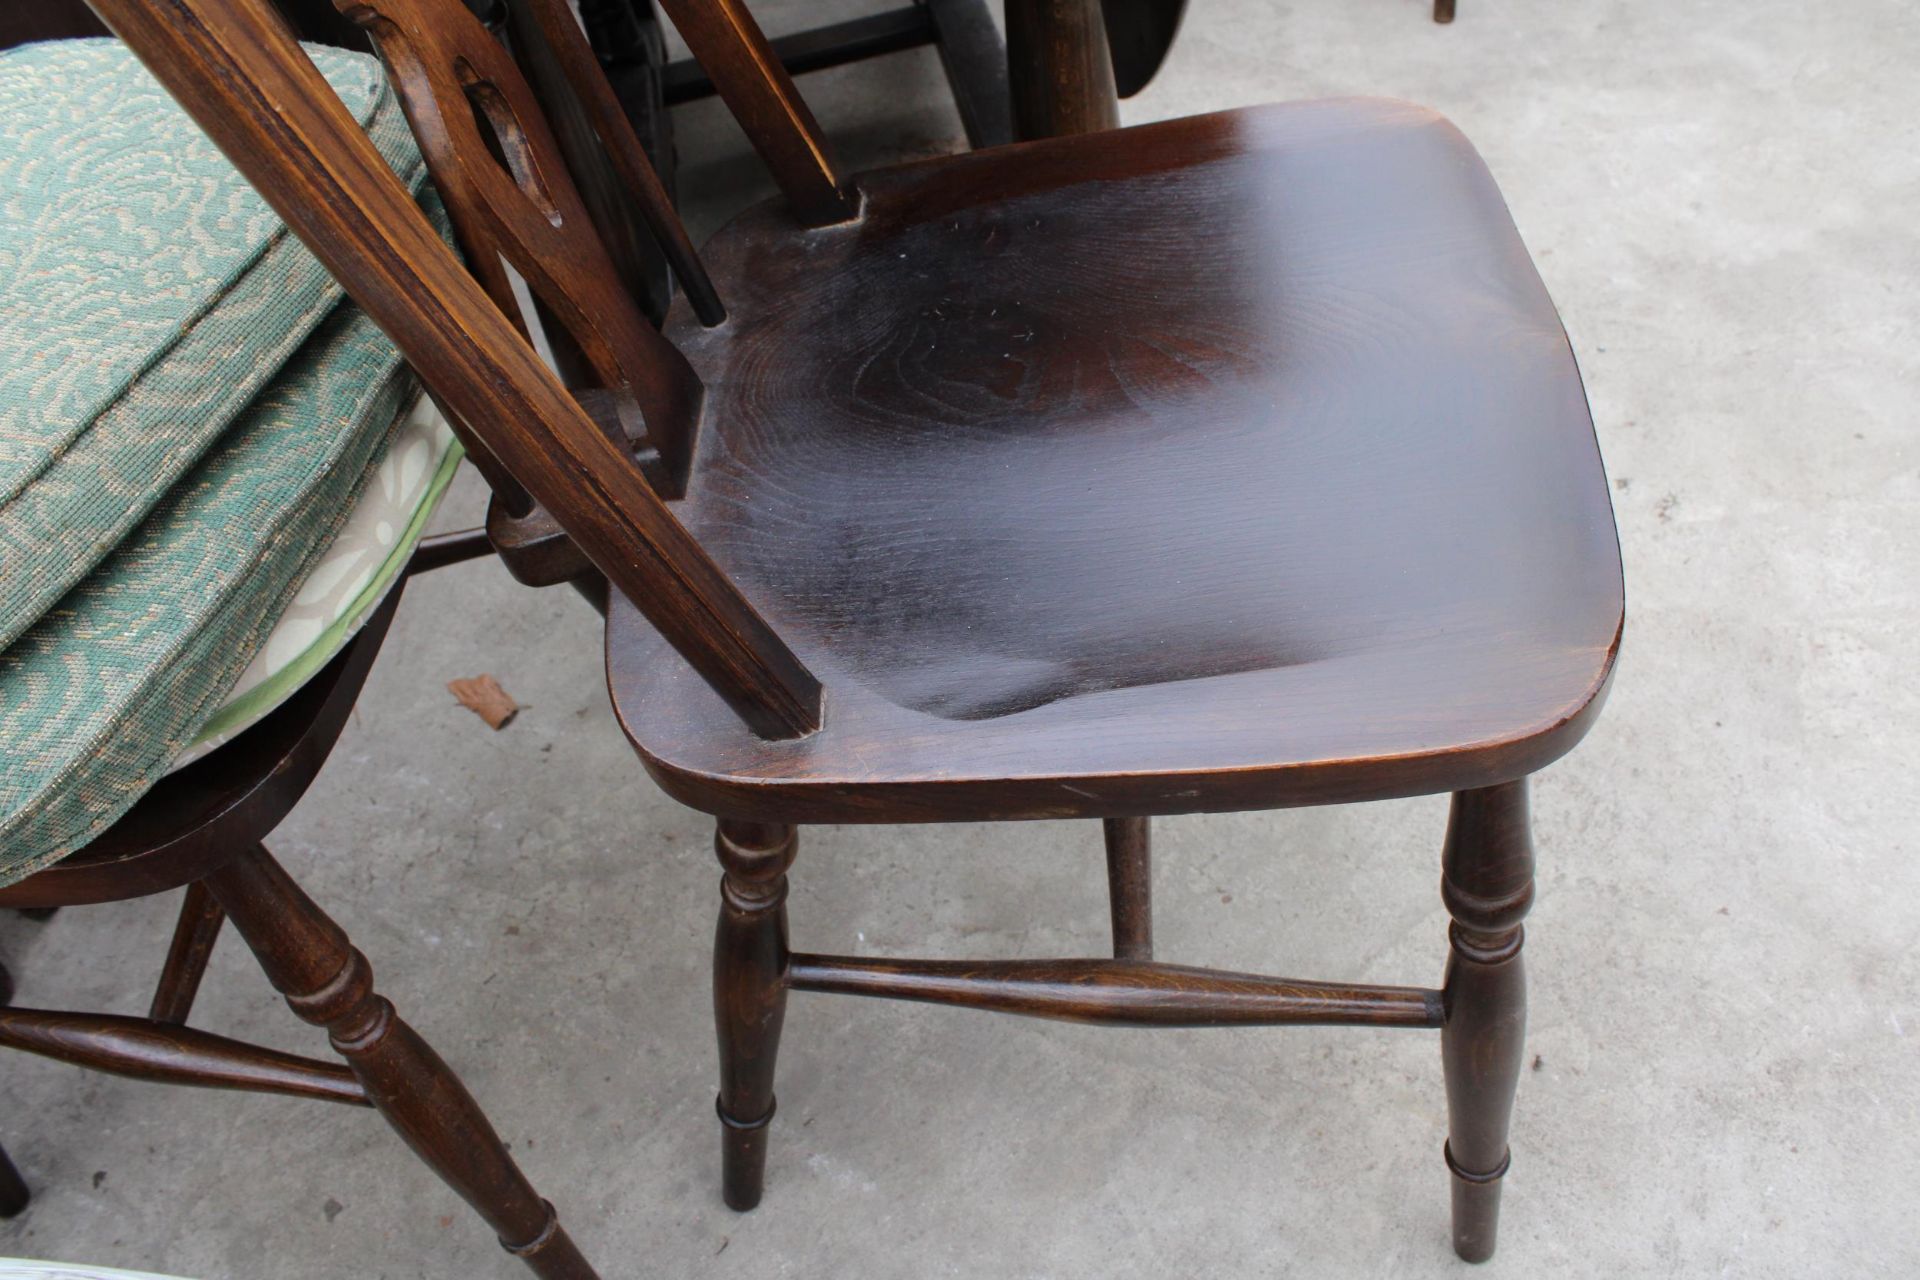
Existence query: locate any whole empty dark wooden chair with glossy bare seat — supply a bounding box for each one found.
[94,0,1622,1259]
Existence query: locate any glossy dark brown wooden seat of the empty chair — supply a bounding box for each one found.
[609,100,1622,821]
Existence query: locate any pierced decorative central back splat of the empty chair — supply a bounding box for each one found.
[338,0,701,478]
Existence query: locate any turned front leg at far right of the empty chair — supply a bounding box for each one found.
[1440,779,1534,1263]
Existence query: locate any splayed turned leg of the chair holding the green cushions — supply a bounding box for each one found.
[205,846,593,1280]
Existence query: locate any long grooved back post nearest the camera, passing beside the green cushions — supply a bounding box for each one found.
[90,0,820,739]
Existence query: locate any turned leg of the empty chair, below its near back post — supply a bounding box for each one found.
[714,819,797,1211]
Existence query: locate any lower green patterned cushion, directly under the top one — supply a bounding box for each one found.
[0,303,417,883]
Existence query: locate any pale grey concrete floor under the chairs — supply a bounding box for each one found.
[0,0,1920,1280]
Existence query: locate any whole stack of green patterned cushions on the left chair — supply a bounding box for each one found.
[0,40,457,883]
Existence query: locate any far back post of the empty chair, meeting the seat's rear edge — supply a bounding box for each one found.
[660,0,860,226]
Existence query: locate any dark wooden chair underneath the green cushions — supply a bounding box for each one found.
[0,564,593,1280]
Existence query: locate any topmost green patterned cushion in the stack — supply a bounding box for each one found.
[0,40,424,647]
